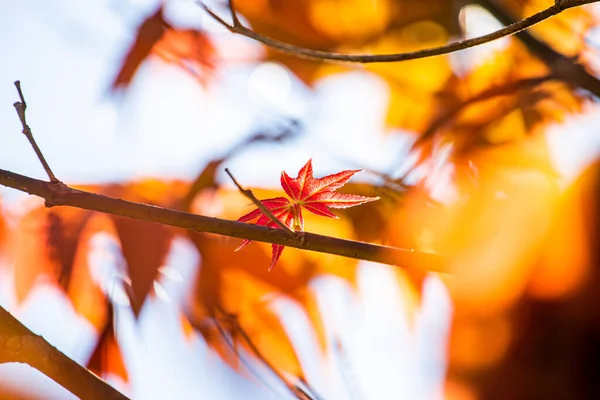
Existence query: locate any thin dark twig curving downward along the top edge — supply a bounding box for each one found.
[200,0,600,64]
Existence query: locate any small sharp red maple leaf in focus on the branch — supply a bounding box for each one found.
[236,159,379,270]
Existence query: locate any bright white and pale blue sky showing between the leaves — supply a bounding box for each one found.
[0,0,600,400]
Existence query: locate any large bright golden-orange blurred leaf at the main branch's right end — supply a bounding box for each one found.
[388,135,560,313]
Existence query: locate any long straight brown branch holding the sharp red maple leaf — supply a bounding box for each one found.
[0,169,446,272]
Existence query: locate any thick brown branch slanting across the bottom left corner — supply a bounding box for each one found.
[0,307,127,400]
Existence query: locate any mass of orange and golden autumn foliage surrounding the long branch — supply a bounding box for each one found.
[0,0,600,400]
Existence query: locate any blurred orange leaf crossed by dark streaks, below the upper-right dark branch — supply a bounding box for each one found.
[414,43,585,170]
